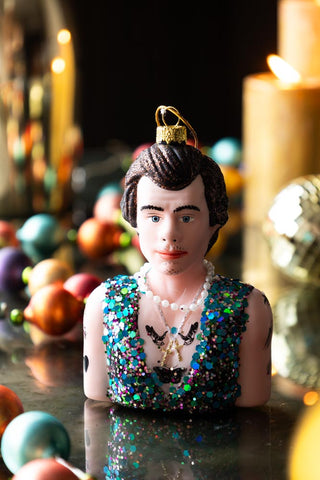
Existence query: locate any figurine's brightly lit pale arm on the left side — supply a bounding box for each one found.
[83,284,109,401]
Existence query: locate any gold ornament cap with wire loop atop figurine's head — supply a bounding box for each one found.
[155,105,198,148]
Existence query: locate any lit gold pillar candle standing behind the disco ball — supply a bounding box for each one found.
[243,73,320,226]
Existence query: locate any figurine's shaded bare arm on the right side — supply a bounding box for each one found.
[236,289,273,407]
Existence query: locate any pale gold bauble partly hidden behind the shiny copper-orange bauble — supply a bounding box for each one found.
[28,258,74,295]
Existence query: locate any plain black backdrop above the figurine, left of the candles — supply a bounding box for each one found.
[63,0,277,149]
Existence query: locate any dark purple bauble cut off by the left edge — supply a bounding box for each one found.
[0,247,32,292]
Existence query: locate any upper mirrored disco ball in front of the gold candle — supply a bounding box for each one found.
[263,175,320,285]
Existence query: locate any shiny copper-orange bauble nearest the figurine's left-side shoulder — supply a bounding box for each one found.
[23,283,84,335]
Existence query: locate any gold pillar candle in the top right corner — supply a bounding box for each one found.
[278,0,320,77]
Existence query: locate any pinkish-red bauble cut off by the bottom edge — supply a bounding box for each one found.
[12,458,78,480]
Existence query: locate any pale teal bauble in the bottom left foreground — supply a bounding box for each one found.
[1,411,70,473]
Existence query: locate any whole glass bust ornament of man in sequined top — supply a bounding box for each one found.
[84,107,272,413]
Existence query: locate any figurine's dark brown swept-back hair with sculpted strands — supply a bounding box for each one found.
[120,143,228,250]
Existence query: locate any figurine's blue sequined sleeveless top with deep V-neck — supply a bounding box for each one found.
[102,275,253,413]
